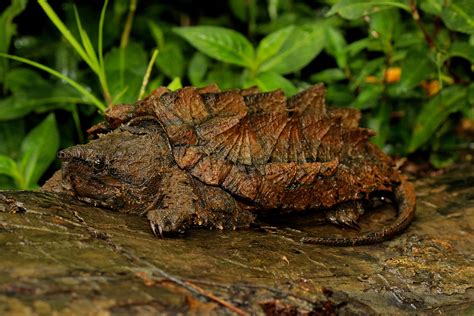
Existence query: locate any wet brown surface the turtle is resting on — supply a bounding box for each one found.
[0,165,474,315]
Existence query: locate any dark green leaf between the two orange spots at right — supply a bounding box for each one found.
[395,50,436,93]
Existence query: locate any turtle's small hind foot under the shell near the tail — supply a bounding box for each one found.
[325,201,365,230]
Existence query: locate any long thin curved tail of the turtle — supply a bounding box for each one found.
[301,175,416,246]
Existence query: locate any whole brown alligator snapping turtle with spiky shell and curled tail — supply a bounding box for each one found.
[44,85,415,245]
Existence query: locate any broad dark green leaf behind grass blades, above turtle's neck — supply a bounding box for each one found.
[105,42,148,103]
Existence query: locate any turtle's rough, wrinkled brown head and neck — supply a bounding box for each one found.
[58,127,173,213]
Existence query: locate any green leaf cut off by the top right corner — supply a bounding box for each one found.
[441,0,474,34]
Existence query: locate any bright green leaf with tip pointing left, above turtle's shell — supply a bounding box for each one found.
[173,26,254,68]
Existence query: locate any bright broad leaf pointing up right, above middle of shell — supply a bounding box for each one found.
[258,23,325,74]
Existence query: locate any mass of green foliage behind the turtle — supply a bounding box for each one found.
[0,0,474,189]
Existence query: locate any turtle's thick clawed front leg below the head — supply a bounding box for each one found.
[147,168,255,236]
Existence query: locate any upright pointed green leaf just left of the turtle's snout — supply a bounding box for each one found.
[19,113,59,189]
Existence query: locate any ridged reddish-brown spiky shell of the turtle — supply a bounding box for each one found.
[92,84,400,211]
